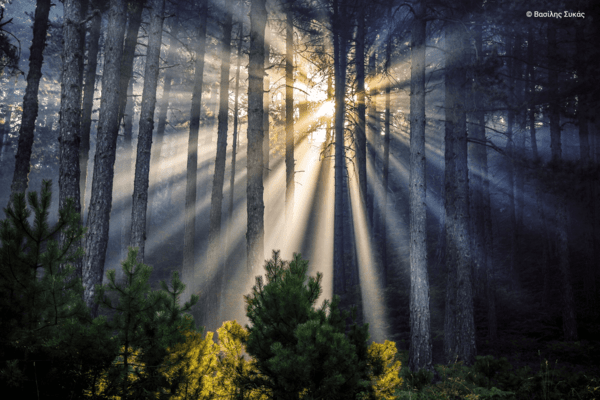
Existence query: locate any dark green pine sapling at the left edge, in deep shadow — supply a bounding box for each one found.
[0,181,113,398]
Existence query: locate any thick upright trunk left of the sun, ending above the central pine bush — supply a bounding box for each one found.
[246,0,267,273]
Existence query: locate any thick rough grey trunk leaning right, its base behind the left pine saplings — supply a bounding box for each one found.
[83,0,125,316]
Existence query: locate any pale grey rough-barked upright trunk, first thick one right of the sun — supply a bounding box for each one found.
[409,1,432,372]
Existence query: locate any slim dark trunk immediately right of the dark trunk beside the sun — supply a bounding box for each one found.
[356,5,367,205]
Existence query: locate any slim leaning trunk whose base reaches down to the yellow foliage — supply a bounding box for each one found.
[206,0,233,326]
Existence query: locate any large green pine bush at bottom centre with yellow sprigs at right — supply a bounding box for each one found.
[244,251,399,399]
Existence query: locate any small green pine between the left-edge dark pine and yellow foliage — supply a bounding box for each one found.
[92,248,198,398]
